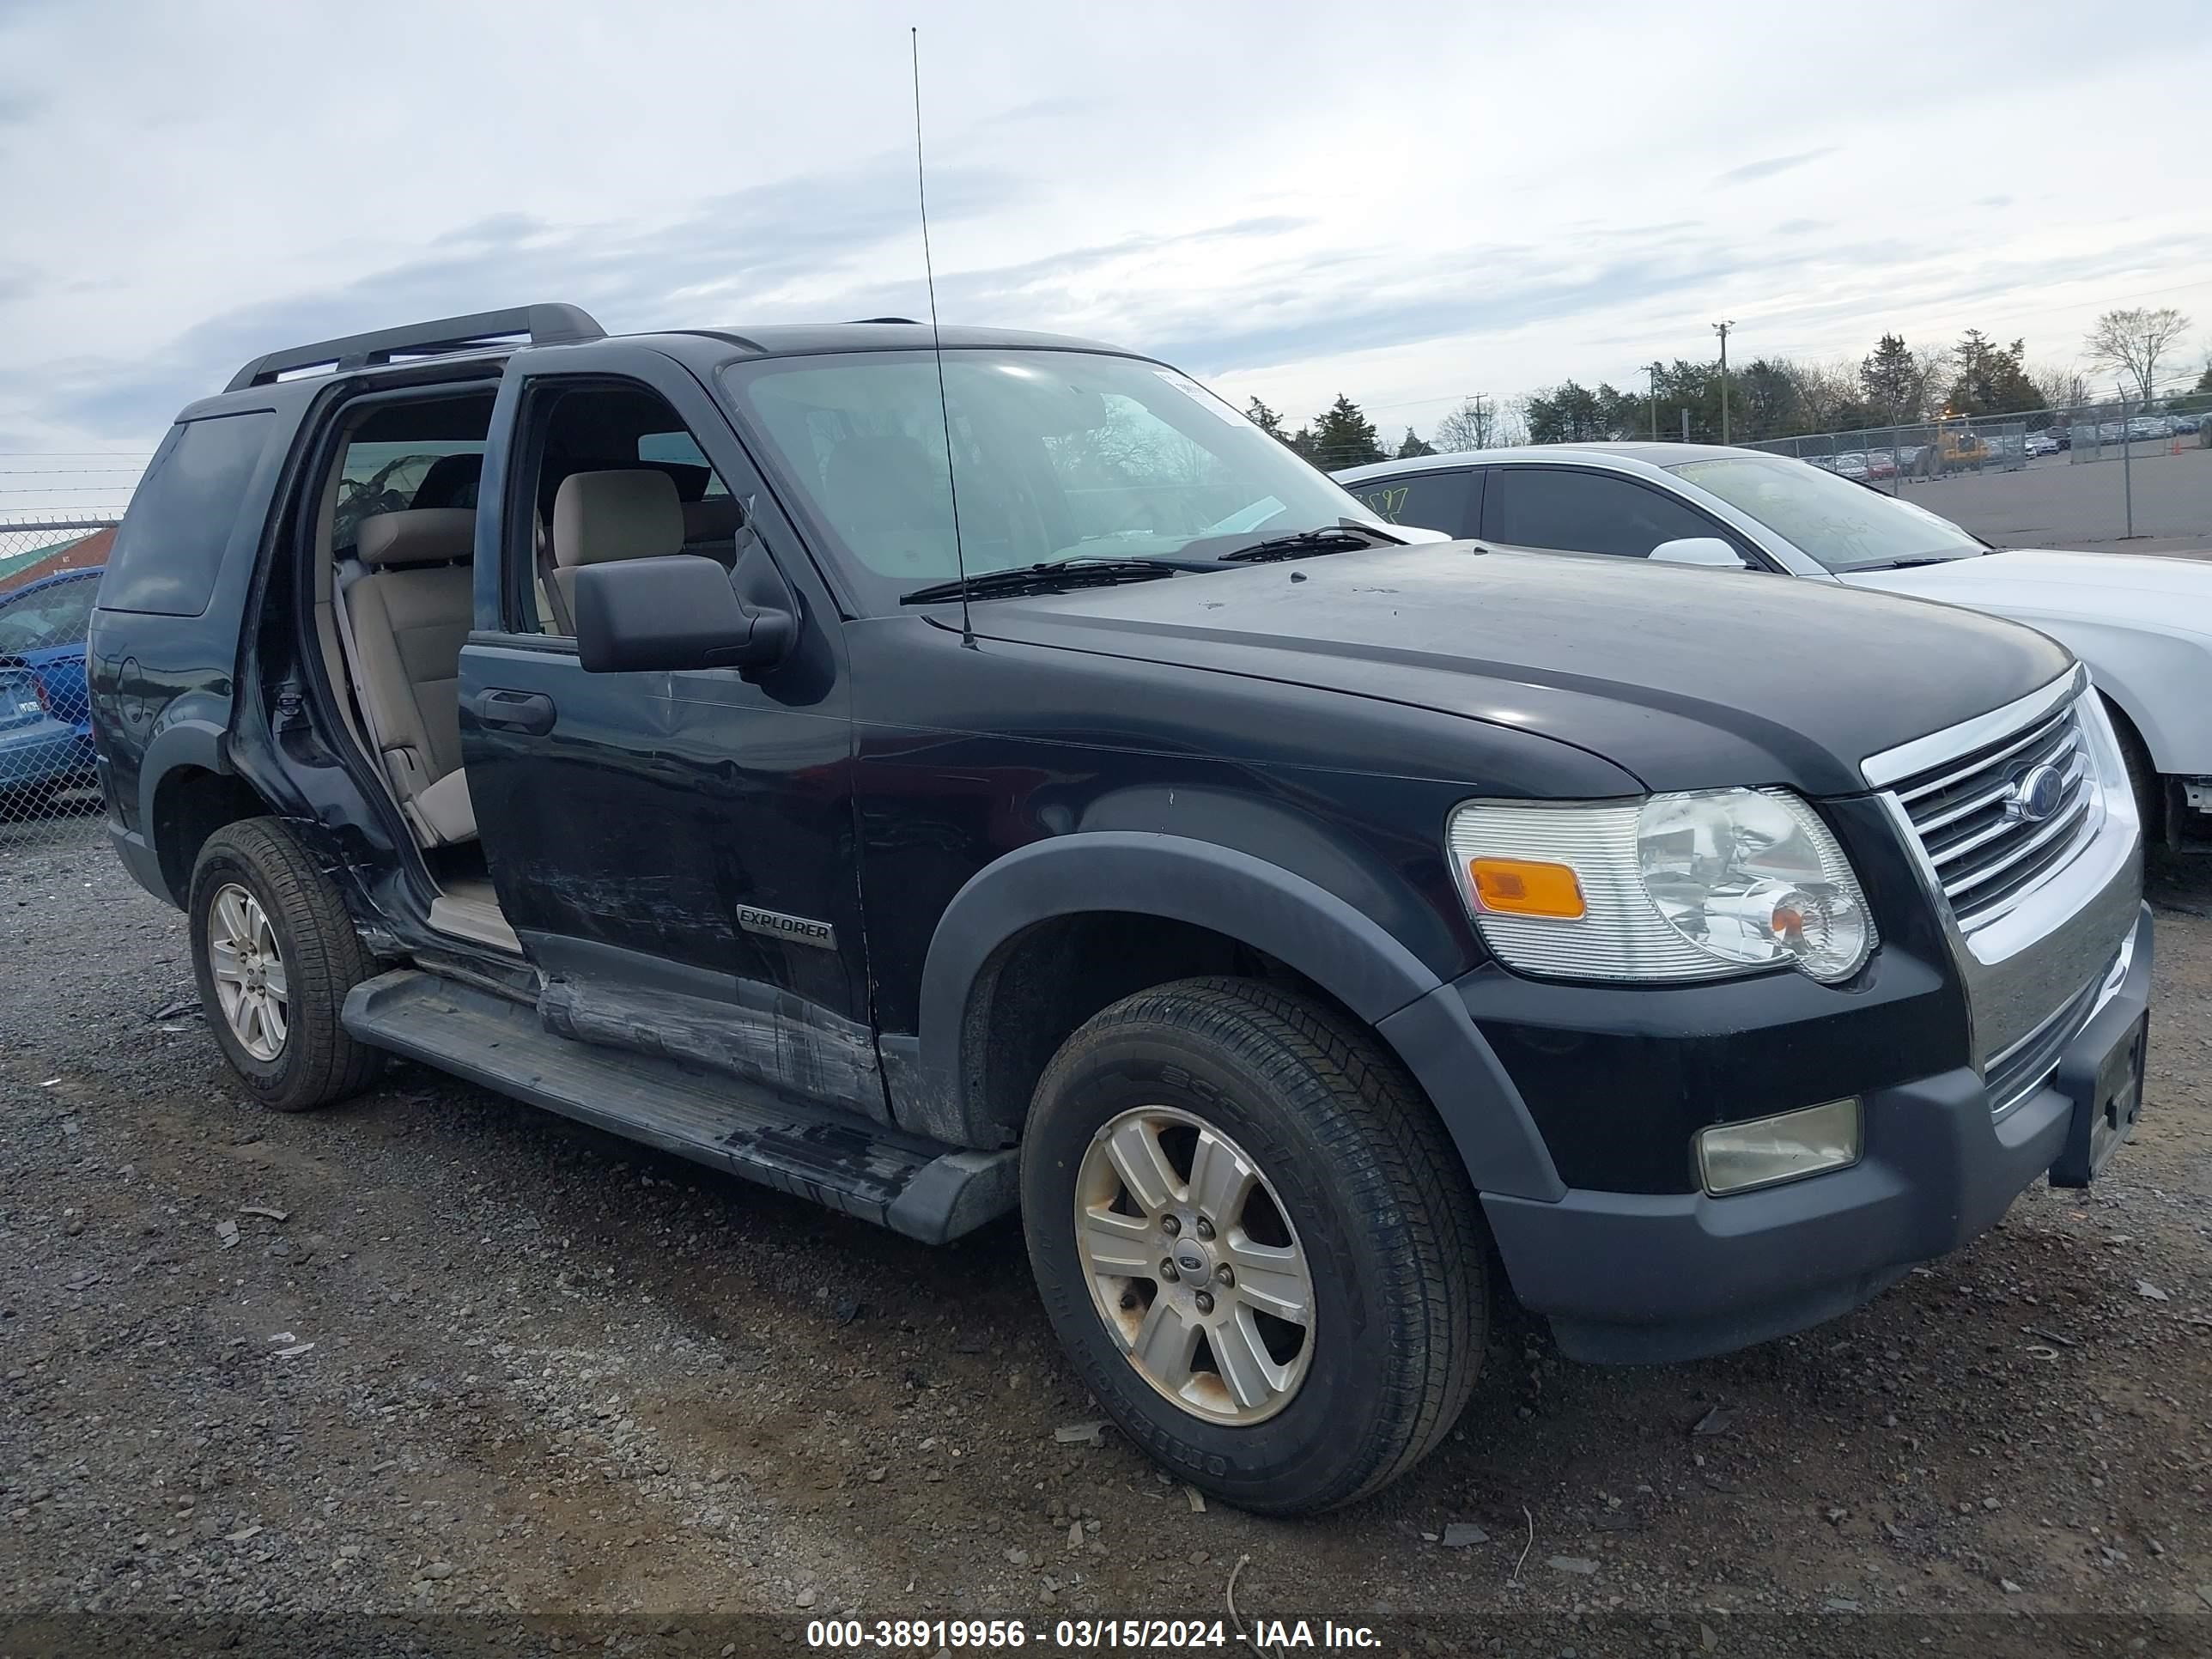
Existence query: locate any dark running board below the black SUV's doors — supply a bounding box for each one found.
[343,969,1018,1243]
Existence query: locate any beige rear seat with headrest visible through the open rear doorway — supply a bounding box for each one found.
[341,507,476,845]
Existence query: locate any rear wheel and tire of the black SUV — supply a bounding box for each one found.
[191,818,383,1113]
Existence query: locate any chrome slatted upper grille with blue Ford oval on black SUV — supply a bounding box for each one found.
[1896,702,2097,931]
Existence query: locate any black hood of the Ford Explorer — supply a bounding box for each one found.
[973,542,2073,794]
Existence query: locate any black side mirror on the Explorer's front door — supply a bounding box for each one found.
[575,553,799,675]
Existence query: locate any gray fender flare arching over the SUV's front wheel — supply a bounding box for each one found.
[918,830,1566,1201]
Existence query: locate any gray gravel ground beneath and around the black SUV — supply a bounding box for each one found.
[0,818,2212,1655]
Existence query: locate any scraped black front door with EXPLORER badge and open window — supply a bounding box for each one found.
[460,345,884,1117]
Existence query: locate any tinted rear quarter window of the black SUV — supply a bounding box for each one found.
[100,410,274,617]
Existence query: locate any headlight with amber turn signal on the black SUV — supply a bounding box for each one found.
[1447,790,1875,984]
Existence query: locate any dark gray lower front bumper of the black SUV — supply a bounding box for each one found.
[1482,907,2150,1363]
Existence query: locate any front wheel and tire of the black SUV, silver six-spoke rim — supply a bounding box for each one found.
[1022,980,1489,1516]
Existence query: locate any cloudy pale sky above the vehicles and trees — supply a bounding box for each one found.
[0,0,2212,515]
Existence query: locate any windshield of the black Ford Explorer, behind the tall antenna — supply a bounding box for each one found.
[723,349,1378,604]
